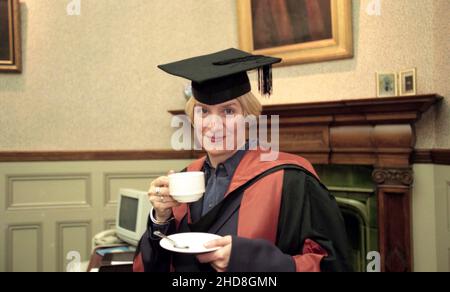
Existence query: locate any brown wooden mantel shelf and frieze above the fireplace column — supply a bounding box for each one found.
[264,94,442,167]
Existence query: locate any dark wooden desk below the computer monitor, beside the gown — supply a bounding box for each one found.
[87,245,134,272]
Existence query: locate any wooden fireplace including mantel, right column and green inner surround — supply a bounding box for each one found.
[263,94,442,272]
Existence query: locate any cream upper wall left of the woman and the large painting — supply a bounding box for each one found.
[0,0,236,150]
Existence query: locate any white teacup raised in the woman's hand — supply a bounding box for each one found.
[169,171,205,203]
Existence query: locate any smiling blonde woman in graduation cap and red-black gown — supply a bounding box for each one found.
[134,49,350,272]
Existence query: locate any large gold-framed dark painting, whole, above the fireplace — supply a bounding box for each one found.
[237,0,353,65]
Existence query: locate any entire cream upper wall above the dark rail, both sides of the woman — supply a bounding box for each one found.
[0,0,450,151]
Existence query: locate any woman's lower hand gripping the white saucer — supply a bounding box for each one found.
[197,235,232,272]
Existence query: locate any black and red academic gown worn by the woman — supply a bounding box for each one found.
[134,151,351,272]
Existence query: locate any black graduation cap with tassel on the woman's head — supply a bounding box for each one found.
[158,48,281,105]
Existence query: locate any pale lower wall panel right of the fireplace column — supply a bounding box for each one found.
[412,164,450,272]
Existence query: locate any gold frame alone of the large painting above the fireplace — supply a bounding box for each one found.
[237,0,353,66]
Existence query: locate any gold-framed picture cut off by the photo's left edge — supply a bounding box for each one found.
[0,0,22,73]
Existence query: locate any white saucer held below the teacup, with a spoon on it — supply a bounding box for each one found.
[159,232,221,253]
